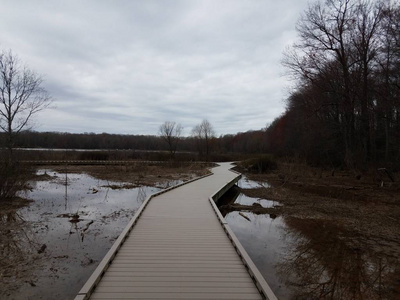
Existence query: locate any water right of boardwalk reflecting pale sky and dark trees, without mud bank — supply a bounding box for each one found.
[219,176,400,300]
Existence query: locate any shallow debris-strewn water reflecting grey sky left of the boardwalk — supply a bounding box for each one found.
[0,170,160,299]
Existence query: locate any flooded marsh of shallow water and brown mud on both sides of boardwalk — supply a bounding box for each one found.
[0,166,400,299]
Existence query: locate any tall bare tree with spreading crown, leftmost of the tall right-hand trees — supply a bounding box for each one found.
[283,0,355,164]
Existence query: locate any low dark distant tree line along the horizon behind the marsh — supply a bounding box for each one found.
[0,130,268,155]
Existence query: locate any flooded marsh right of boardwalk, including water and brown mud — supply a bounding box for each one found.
[227,166,400,299]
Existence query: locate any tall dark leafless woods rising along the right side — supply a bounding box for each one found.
[274,0,400,169]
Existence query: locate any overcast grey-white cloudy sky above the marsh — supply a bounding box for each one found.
[0,0,308,135]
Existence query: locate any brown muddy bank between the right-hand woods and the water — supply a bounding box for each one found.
[231,164,400,254]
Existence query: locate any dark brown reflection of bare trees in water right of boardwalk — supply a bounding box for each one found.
[277,218,400,299]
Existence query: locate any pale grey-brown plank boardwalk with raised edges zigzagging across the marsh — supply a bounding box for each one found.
[75,163,276,300]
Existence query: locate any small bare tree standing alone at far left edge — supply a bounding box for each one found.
[0,51,51,157]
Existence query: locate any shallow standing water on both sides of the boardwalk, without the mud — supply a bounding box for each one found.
[0,170,400,300]
